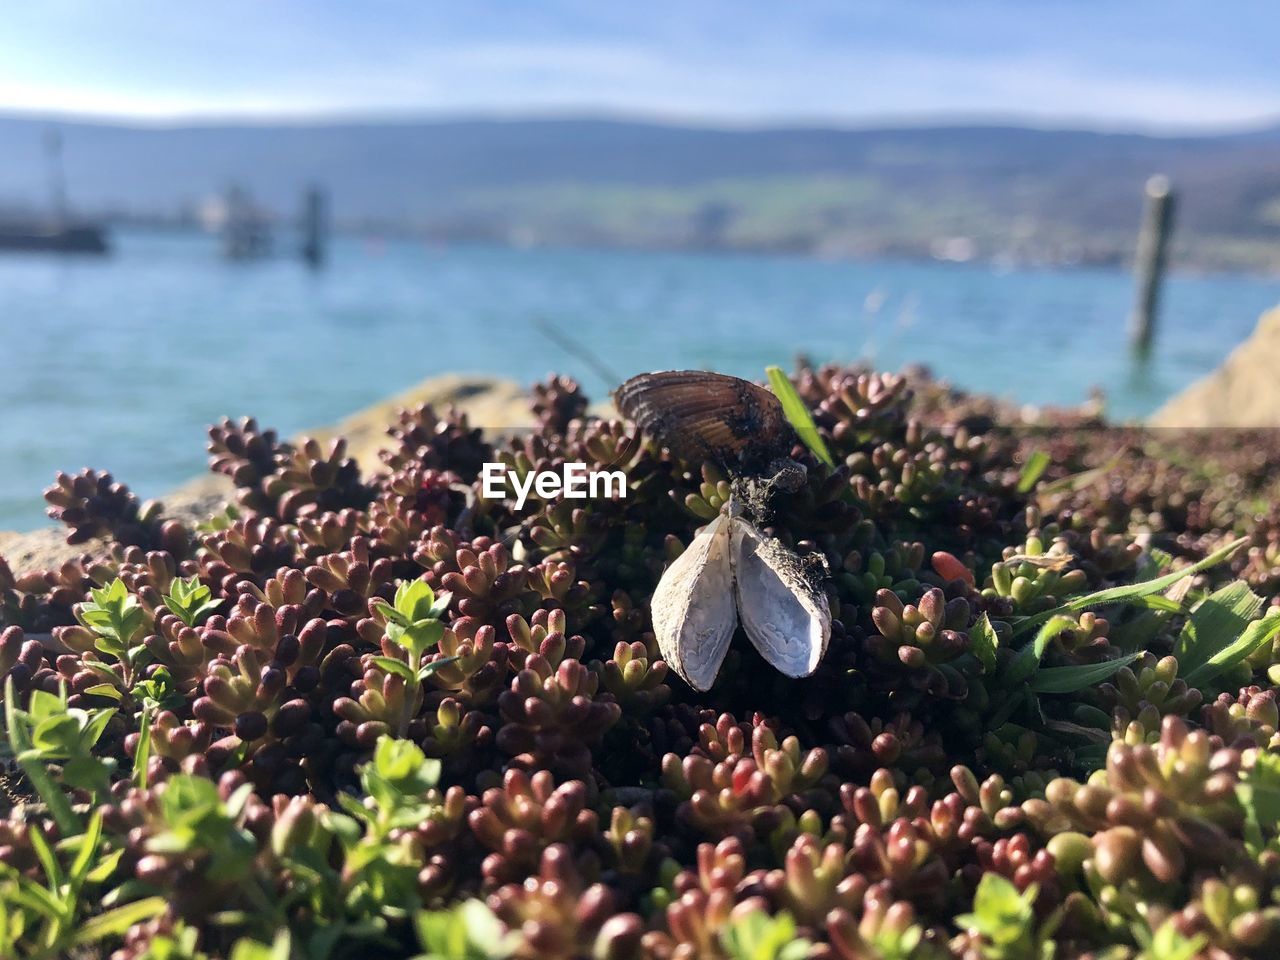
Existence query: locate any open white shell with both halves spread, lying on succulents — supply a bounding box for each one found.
[650,513,831,690]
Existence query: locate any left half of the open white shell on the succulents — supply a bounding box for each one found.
[649,513,737,690]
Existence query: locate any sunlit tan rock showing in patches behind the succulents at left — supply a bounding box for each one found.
[0,374,534,573]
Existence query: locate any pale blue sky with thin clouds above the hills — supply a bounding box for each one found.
[0,0,1280,129]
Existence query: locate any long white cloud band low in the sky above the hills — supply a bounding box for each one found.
[0,41,1280,129]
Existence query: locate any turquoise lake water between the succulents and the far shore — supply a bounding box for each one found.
[0,233,1280,530]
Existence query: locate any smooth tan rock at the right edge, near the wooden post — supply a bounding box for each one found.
[1148,307,1280,428]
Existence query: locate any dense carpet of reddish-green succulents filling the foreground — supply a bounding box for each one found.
[0,365,1280,960]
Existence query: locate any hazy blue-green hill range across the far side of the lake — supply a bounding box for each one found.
[0,116,1280,269]
